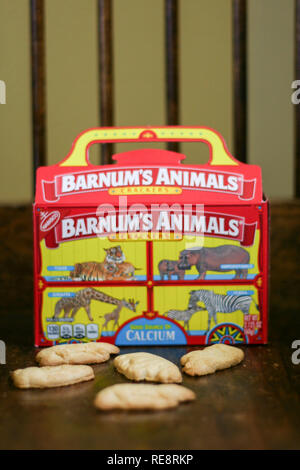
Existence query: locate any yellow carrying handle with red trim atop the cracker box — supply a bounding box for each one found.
[59,126,242,166]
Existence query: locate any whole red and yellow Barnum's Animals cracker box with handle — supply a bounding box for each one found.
[33,126,268,346]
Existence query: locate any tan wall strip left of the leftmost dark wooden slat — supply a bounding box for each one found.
[0,0,32,203]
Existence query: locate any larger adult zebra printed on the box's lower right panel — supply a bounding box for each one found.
[188,289,258,332]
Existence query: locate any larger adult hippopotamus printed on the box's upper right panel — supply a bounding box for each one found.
[178,245,249,279]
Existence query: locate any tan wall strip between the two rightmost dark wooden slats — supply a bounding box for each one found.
[248,0,299,197]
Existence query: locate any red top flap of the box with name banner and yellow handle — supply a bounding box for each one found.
[35,126,263,206]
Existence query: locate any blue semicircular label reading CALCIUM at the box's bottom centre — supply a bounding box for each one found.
[116,318,187,346]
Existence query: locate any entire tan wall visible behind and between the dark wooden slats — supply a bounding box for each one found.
[0,0,299,203]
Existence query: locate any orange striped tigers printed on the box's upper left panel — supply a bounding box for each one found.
[70,245,138,281]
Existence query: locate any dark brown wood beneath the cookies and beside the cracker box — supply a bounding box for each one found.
[0,202,300,449]
